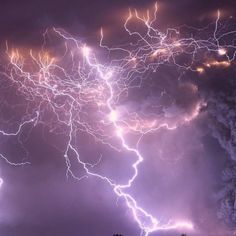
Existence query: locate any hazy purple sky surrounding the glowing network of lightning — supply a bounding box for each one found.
[0,0,236,236]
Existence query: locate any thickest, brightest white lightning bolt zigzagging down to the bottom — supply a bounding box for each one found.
[74,48,193,236]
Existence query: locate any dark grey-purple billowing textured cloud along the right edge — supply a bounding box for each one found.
[202,75,236,227]
